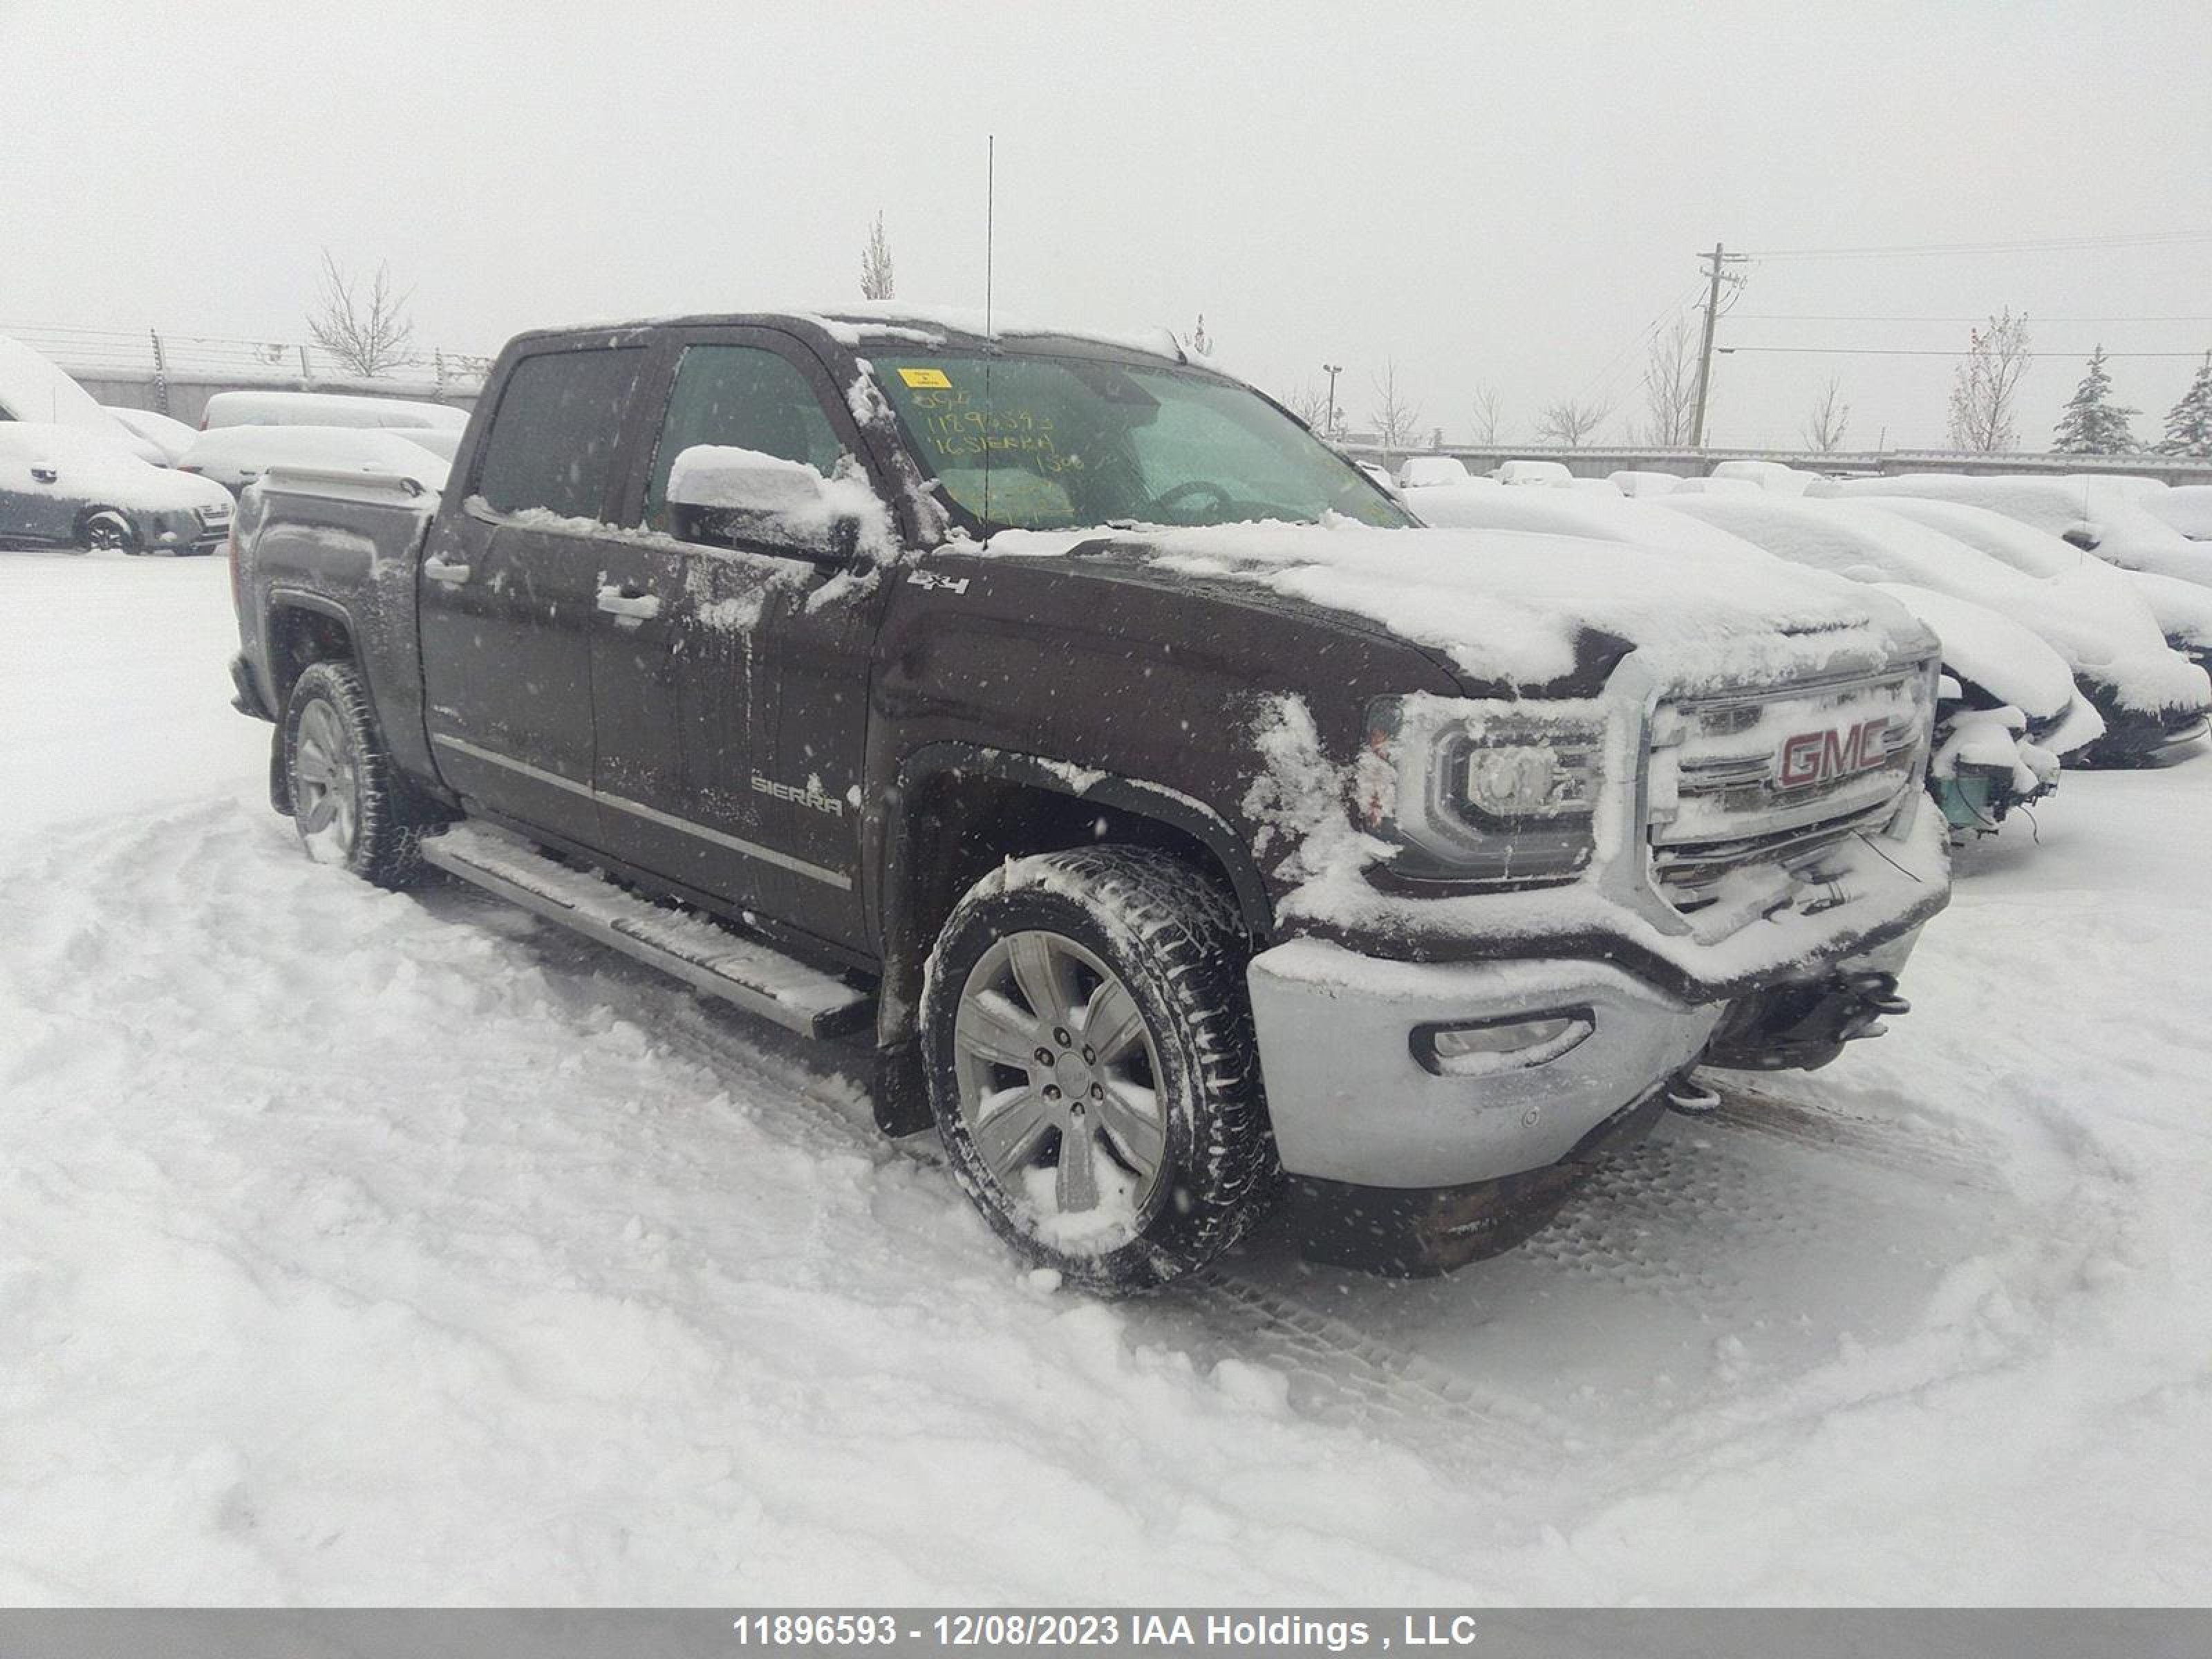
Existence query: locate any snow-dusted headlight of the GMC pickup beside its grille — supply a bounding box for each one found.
[1362,697,1606,883]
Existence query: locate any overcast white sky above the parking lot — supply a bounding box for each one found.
[0,0,2212,447]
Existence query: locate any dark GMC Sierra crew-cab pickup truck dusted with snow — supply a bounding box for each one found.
[234,310,1949,1285]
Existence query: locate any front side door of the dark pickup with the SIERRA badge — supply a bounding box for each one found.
[590,328,874,938]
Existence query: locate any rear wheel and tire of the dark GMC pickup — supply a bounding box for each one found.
[283,659,422,887]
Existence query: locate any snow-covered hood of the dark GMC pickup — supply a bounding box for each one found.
[988,518,1933,690]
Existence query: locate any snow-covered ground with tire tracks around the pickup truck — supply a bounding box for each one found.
[0,553,2212,1604]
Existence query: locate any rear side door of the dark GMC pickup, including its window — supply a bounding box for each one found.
[418,339,646,847]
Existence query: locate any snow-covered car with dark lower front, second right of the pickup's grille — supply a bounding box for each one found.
[1663,494,2212,765]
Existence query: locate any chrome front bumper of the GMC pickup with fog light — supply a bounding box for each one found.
[1248,927,1920,1188]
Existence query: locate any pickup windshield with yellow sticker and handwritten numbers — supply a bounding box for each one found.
[876,352,1414,535]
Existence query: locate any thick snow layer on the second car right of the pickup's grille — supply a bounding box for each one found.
[1659,496,2205,712]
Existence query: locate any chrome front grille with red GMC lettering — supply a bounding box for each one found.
[1648,666,1931,914]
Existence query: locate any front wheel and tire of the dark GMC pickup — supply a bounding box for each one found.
[922,847,1281,1290]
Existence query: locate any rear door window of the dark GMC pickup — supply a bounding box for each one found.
[476,345,646,518]
